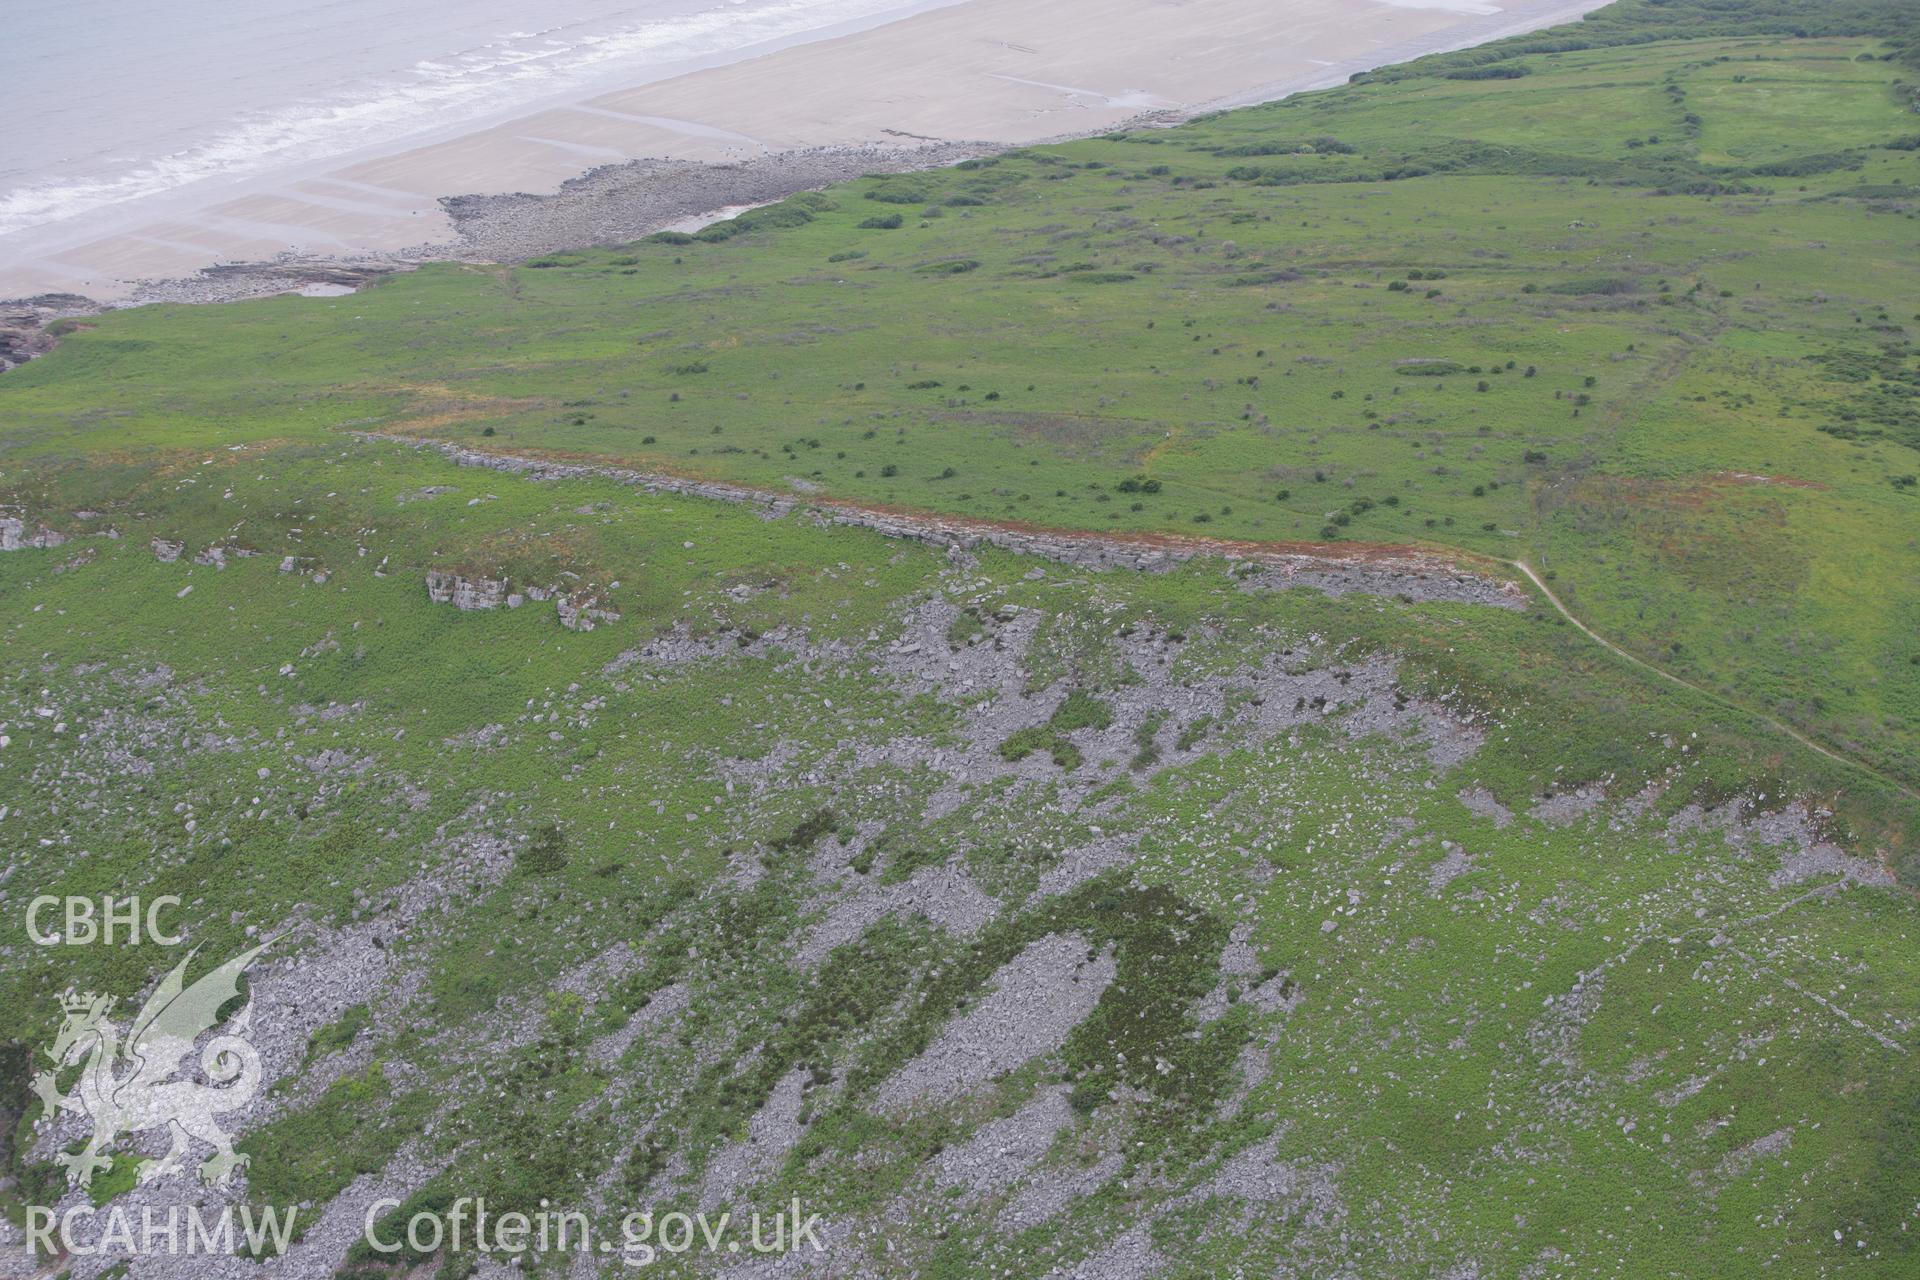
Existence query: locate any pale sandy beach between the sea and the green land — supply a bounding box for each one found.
[0,0,1599,303]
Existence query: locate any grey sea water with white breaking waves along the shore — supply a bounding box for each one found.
[0,0,927,246]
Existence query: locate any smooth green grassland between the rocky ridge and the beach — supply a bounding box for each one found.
[0,20,1920,781]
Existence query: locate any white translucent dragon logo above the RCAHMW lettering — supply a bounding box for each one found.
[33,944,265,1186]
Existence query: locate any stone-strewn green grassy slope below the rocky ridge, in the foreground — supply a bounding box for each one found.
[0,427,1920,1274]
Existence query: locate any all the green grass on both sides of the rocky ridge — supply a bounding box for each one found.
[0,2,1920,1278]
